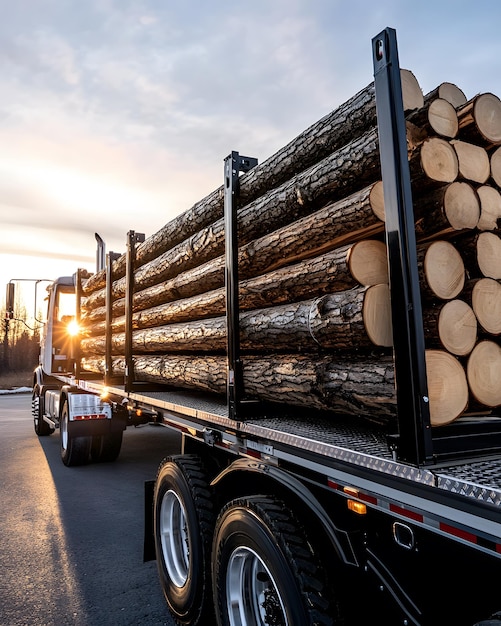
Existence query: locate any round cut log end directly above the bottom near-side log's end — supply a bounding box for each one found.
[438,300,477,356]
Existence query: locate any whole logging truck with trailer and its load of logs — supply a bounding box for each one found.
[21,29,501,626]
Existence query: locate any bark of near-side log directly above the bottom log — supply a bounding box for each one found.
[80,287,373,356]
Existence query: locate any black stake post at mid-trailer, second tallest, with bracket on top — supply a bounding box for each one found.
[224,151,257,420]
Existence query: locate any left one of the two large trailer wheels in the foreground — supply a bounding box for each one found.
[153,455,215,626]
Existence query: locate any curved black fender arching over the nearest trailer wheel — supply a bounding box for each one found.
[210,458,359,567]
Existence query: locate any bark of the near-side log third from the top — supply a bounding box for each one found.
[83,184,384,320]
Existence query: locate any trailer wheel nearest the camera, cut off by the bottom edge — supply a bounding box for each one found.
[212,496,334,626]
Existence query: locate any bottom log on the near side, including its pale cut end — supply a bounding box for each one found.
[83,350,466,426]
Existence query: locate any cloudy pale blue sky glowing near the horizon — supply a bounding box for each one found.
[0,0,501,322]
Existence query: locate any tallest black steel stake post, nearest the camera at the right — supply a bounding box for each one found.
[372,28,433,465]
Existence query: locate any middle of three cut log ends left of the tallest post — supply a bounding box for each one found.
[346,239,388,287]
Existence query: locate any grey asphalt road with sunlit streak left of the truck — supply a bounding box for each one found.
[0,394,179,626]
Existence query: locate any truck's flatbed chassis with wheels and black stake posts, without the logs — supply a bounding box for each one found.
[26,29,501,626]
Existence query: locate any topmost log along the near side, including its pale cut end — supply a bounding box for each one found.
[84,70,423,294]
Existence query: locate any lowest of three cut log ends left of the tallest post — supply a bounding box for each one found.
[362,284,393,348]
